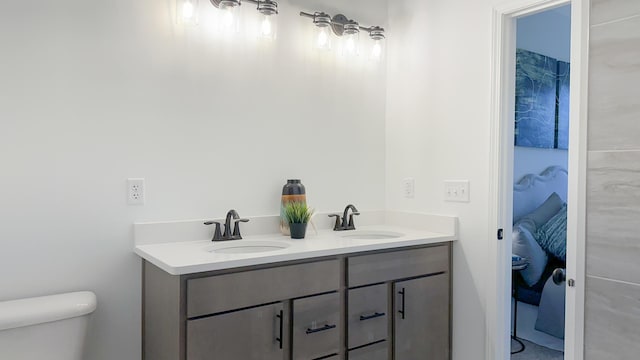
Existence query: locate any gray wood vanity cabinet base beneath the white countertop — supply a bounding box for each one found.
[142,243,451,360]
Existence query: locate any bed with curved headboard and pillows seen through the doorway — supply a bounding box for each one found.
[512,166,568,338]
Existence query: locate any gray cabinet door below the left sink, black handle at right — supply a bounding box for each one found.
[187,303,287,360]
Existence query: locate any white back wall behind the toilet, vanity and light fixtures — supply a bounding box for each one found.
[0,0,387,360]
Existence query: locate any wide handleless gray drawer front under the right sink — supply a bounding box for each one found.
[347,245,449,287]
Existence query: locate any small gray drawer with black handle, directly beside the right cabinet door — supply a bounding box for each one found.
[347,284,389,349]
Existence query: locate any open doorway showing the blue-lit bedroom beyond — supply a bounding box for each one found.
[507,4,571,360]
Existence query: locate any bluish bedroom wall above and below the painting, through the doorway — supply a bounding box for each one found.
[513,5,571,181]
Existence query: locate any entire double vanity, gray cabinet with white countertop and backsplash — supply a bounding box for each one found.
[135,212,456,360]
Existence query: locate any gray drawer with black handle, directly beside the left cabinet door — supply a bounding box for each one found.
[292,293,342,360]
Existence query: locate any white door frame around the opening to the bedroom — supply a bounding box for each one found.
[486,0,589,360]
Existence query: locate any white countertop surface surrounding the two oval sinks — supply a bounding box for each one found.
[134,225,456,275]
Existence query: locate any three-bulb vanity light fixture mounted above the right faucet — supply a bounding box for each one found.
[300,11,385,60]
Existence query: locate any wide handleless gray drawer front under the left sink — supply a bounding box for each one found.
[187,260,340,318]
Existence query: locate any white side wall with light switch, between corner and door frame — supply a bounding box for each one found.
[386,0,501,360]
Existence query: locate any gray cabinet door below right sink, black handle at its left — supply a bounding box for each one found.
[394,273,450,360]
